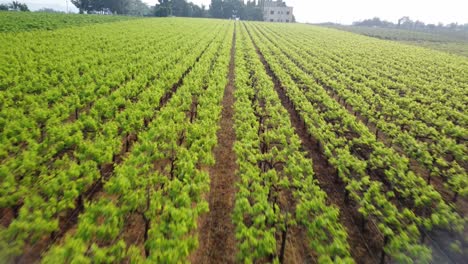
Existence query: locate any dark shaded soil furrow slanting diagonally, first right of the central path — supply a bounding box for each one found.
[245,24,383,263]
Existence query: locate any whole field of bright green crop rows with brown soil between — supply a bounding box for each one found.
[0,14,468,263]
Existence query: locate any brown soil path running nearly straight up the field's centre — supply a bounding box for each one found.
[189,23,237,263]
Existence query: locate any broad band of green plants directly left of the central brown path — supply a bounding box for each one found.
[43,20,233,263]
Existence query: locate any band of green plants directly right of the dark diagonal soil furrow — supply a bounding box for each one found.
[245,22,464,261]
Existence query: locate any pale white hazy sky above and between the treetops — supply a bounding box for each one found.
[4,0,468,24]
